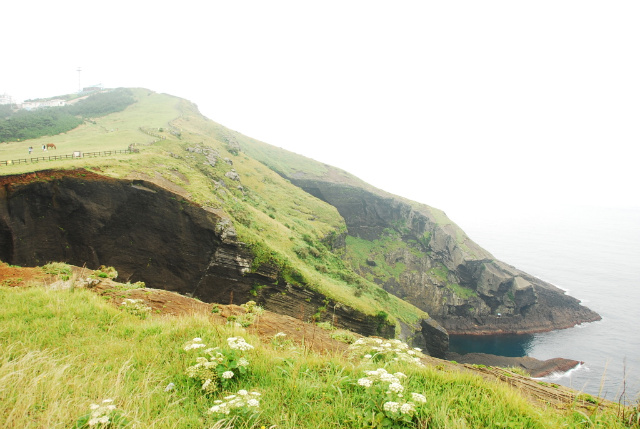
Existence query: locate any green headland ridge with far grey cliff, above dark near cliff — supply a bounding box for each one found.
[0,89,600,342]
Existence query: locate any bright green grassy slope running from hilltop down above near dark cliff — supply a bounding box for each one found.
[0,89,426,324]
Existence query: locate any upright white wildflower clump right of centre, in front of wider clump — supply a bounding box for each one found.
[358,368,427,422]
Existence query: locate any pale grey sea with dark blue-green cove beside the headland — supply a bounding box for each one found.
[448,202,640,402]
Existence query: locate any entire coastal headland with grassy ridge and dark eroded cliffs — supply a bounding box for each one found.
[0,89,600,357]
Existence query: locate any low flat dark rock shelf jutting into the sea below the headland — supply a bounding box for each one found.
[446,352,584,378]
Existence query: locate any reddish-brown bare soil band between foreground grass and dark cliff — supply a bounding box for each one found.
[0,262,617,412]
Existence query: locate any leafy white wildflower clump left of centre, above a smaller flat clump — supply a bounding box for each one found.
[184,337,253,393]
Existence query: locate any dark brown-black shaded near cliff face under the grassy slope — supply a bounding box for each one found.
[0,170,448,356]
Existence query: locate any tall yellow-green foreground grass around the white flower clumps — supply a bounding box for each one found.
[0,288,623,429]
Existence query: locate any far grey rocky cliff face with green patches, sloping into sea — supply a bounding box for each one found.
[289,174,600,334]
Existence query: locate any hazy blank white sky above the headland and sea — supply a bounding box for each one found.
[0,0,640,220]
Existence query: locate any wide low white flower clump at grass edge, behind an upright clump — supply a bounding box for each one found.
[349,338,424,366]
